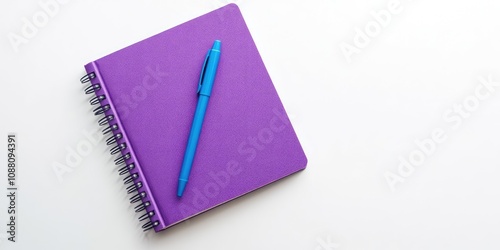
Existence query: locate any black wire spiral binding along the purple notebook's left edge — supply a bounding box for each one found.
[80,72,159,231]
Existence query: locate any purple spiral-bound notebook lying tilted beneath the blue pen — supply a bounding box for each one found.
[82,4,307,231]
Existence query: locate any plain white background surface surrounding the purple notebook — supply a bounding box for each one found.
[0,0,500,250]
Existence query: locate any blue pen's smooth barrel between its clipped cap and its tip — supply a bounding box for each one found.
[179,95,209,181]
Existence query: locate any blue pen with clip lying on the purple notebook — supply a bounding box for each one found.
[177,40,221,197]
